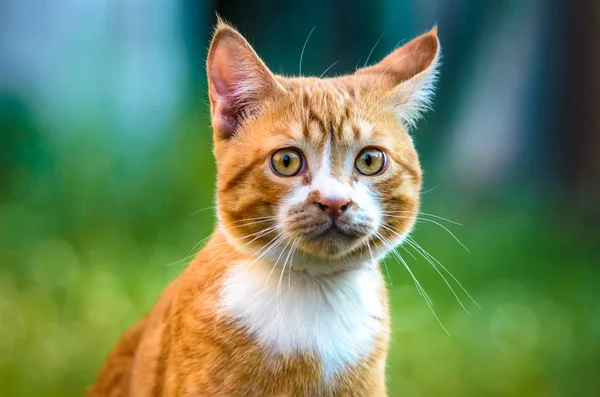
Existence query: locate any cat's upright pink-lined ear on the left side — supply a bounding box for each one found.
[206,20,283,139]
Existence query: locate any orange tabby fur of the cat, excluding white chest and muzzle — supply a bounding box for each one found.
[88,22,439,397]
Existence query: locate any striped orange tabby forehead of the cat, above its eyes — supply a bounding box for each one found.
[266,78,412,165]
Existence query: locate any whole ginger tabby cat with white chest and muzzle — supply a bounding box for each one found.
[88,22,440,397]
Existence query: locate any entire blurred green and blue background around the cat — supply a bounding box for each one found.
[0,0,600,397]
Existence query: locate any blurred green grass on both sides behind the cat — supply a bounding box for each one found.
[0,113,600,396]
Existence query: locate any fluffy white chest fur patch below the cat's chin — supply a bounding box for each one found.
[221,263,384,379]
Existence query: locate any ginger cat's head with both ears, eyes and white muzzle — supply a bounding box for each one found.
[207,23,440,272]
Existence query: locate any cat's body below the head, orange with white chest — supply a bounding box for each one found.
[95,230,388,396]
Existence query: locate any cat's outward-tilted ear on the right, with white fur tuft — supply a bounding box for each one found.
[356,26,441,126]
